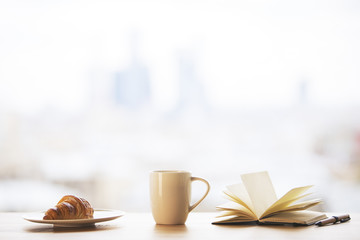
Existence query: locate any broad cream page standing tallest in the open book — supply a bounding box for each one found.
[241,172,277,218]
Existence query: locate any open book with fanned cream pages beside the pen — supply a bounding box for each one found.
[213,172,326,225]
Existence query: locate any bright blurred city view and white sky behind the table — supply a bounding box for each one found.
[0,0,360,211]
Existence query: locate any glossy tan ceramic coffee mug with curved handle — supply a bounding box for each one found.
[150,170,210,224]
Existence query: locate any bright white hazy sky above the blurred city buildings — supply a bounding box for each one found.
[0,1,360,112]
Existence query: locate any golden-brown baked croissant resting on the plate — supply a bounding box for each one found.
[43,195,94,220]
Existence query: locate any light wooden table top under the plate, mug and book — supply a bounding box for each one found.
[0,212,360,240]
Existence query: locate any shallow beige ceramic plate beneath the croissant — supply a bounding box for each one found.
[23,209,124,227]
